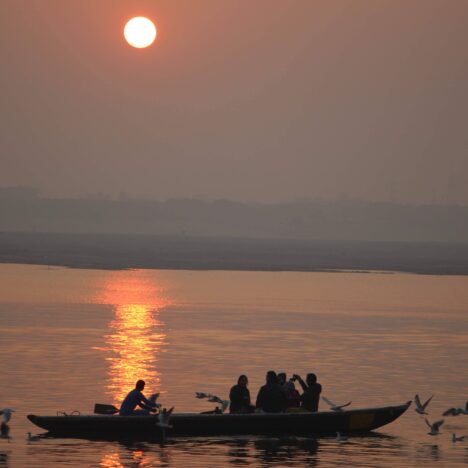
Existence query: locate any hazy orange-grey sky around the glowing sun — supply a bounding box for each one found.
[0,0,468,204]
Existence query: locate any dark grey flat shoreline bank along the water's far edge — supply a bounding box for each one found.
[0,233,468,275]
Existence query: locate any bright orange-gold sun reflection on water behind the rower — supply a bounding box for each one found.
[98,270,168,406]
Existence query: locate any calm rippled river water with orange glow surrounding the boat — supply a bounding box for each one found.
[0,265,468,467]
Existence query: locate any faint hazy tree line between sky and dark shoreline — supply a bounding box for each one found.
[0,188,468,243]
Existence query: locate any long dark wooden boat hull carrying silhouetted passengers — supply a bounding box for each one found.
[28,401,411,439]
